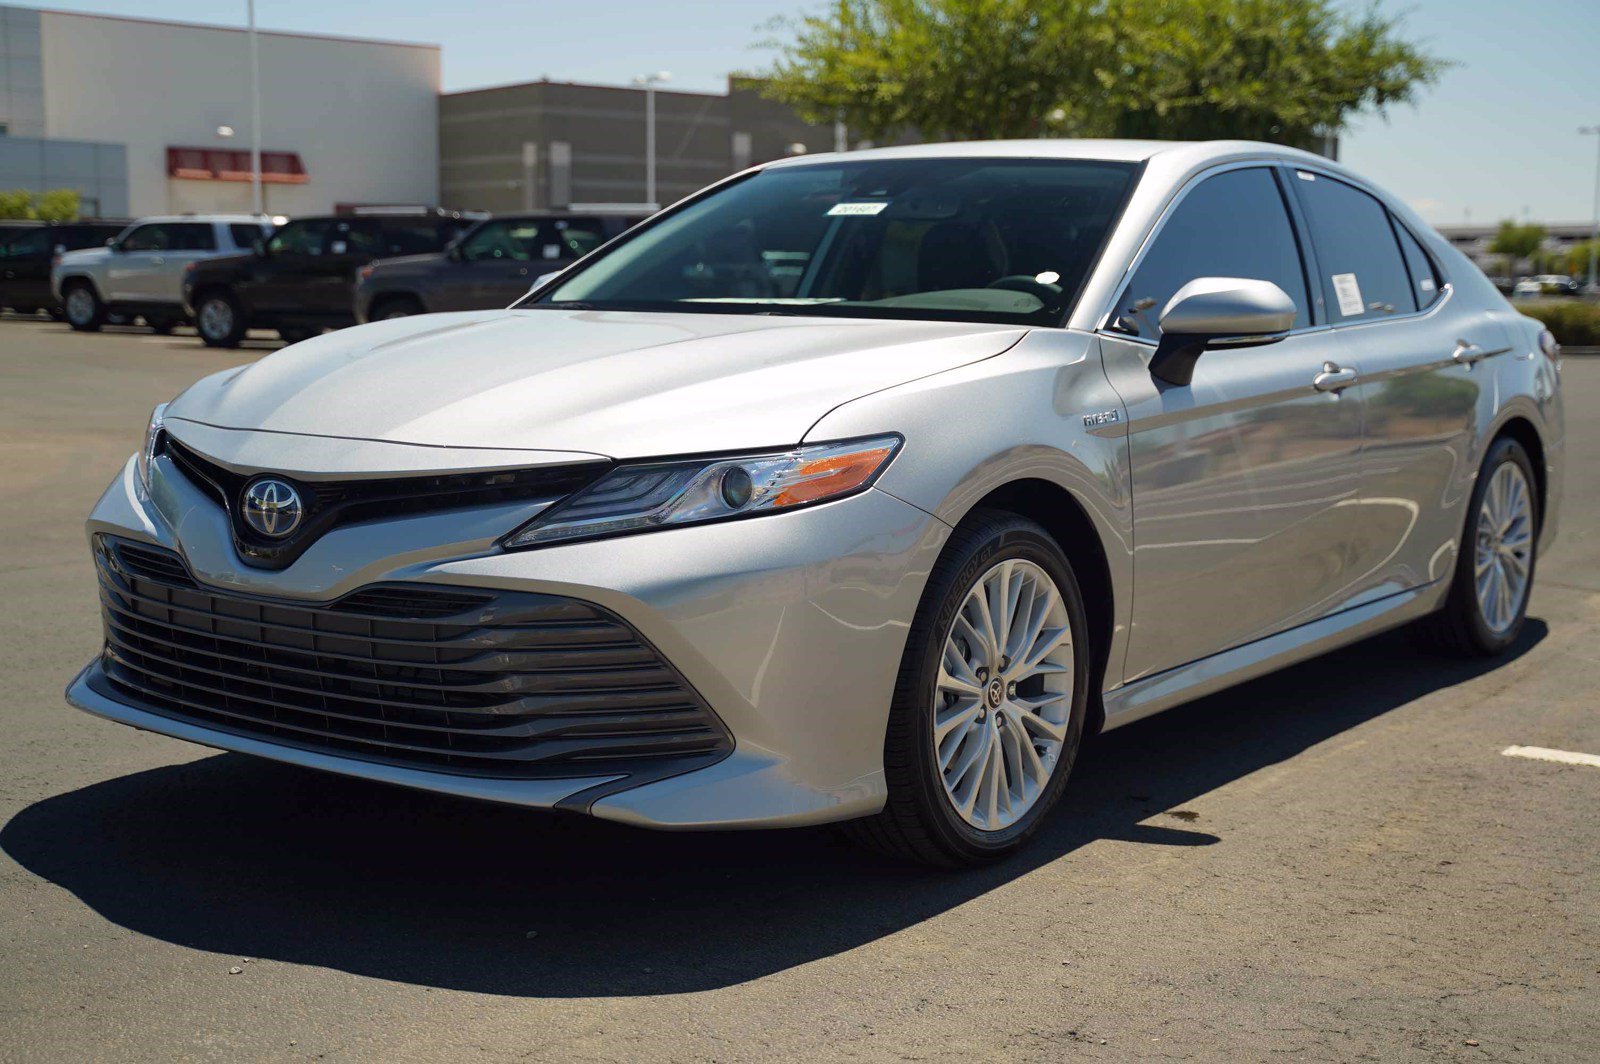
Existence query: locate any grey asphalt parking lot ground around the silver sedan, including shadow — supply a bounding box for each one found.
[0,318,1600,1064]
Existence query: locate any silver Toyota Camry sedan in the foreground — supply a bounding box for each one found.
[67,141,1562,866]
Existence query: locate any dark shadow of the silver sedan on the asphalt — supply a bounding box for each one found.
[0,619,1546,997]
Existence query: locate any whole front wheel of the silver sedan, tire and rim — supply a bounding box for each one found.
[848,512,1090,867]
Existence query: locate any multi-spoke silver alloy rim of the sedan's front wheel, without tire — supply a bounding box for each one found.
[931,558,1074,832]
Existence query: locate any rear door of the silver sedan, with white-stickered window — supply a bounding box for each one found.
[1286,166,1509,598]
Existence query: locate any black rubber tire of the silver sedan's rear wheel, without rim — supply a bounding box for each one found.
[1413,437,1542,658]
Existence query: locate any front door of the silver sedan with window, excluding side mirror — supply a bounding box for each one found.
[1101,165,1362,680]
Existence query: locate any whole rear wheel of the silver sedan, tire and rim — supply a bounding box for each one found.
[1416,437,1539,658]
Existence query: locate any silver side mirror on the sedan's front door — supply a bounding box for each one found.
[1150,277,1294,384]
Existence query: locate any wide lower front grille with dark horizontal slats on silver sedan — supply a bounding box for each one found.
[96,536,733,778]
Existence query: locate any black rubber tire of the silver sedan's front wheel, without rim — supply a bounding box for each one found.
[845,510,1091,867]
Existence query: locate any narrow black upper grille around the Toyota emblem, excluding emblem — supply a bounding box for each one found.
[158,434,611,570]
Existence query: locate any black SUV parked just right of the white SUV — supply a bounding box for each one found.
[182,210,482,347]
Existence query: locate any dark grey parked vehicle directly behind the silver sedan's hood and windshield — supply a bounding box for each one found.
[354,208,650,322]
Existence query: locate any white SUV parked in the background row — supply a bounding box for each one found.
[50,214,270,333]
